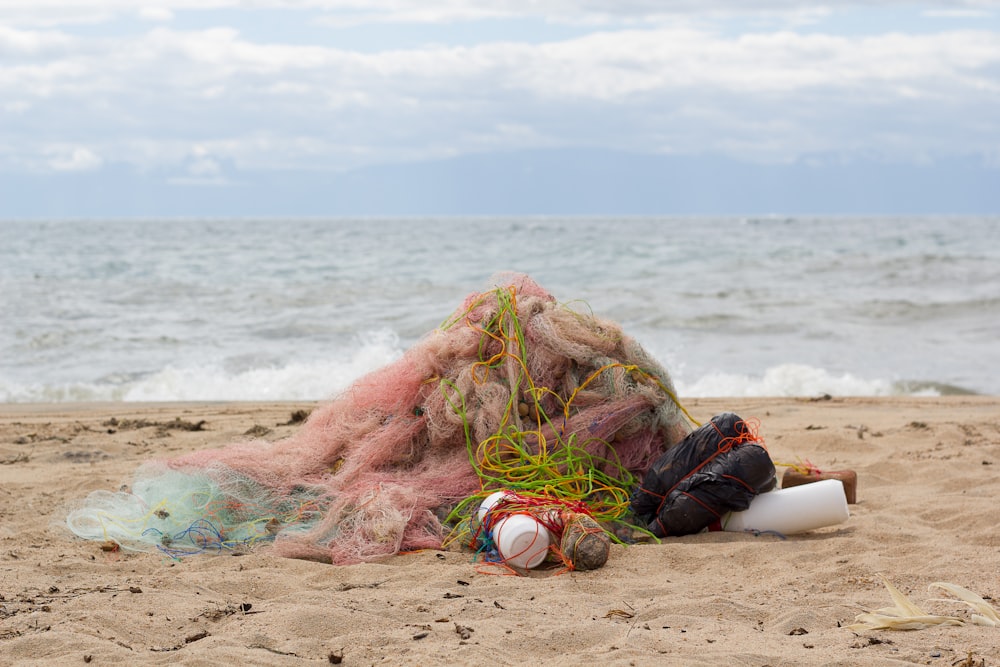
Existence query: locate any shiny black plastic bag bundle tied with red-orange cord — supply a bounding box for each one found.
[630,412,776,537]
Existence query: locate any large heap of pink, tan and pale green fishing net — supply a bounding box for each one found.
[68,274,691,564]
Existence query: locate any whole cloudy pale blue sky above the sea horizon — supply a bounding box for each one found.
[0,0,1000,219]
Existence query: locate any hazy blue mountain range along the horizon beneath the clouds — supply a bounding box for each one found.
[0,149,1000,219]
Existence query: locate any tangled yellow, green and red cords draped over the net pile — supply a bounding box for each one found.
[439,286,700,568]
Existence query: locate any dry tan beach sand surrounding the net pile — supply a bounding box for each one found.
[0,397,1000,667]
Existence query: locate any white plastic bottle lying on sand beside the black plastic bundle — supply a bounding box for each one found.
[722,479,851,535]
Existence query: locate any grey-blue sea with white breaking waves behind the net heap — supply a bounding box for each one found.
[0,217,1000,403]
